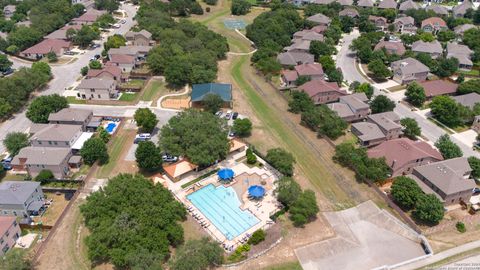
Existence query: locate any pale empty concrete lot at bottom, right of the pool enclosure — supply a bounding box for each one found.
[295,201,425,270]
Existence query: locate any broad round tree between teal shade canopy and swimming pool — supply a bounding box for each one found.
[160,109,230,166]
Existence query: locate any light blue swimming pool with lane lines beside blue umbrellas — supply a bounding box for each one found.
[187,184,260,240]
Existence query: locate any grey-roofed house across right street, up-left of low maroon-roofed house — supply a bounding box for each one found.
[390,57,430,84]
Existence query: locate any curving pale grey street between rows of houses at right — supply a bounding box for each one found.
[337,30,480,157]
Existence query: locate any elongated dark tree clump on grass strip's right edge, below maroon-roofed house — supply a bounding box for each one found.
[288,91,348,140]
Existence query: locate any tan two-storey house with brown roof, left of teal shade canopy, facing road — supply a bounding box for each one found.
[77,78,118,100]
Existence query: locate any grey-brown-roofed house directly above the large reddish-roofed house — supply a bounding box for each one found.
[352,112,402,147]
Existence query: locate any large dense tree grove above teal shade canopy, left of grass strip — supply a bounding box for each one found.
[140,0,228,87]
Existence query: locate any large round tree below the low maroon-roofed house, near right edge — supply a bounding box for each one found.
[430,96,461,127]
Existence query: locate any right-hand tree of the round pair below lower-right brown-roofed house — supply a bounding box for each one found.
[413,194,444,224]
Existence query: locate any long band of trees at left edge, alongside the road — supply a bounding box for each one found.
[0,62,52,119]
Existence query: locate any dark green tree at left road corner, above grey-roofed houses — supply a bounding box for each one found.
[26,94,68,123]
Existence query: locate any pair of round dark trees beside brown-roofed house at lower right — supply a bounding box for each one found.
[391,176,444,224]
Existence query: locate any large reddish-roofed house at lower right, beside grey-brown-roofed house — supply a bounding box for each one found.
[367,138,443,177]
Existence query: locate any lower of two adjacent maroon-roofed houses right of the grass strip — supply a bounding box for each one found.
[298,80,347,104]
